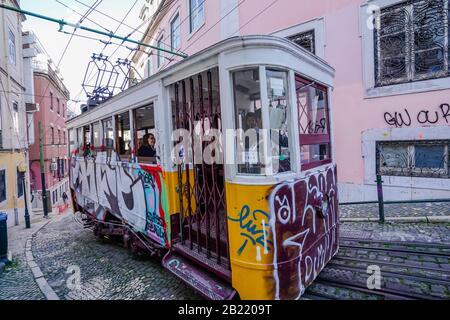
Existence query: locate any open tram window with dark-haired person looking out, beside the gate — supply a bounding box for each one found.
[134,104,157,164]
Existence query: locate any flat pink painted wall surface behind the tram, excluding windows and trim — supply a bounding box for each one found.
[139,0,450,194]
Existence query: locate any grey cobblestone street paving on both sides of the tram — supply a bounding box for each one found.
[0,206,450,300]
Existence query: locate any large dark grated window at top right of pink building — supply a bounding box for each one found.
[374,0,450,87]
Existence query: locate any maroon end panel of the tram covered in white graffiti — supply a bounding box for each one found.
[269,165,339,300]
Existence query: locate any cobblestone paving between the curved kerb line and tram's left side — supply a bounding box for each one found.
[32,215,200,300]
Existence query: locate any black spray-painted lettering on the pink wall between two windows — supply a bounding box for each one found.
[384,103,450,128]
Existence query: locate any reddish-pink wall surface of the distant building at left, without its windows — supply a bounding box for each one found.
[30,73,68,190]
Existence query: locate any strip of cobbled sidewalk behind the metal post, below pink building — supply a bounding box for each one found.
[339,202,450,223]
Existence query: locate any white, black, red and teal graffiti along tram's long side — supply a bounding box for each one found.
[71,153,170,247]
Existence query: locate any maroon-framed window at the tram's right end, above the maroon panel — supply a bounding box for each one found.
[296,76,331,170]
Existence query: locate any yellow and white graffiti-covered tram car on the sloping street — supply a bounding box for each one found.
[68,36,339,299]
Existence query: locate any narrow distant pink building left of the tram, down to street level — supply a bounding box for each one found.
[30,59,70,209]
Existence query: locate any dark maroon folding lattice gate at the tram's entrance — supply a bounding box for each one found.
[171,68,230,273]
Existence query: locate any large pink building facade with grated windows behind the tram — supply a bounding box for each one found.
[133,0,450,202]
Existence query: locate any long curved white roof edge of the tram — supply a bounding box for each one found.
[66,35,335,127]
